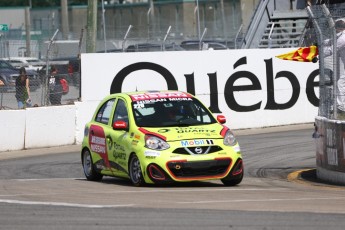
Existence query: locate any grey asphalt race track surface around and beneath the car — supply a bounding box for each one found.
[0,124,345,230]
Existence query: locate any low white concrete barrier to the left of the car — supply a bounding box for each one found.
[0,101,99,152]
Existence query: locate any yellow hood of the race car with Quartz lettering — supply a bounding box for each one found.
[143,123,225,141]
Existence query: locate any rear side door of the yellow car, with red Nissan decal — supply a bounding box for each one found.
[89,98,115,174]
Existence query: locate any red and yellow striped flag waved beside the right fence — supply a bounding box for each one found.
[276,46,319,62]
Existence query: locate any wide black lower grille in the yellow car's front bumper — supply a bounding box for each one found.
[167,158,231,179]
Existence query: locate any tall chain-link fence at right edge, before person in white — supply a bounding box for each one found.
[305,4,345,119]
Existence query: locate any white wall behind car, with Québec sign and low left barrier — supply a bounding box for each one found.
[0,49,319,151]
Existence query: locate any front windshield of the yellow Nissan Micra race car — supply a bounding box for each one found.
[132,98,216,127]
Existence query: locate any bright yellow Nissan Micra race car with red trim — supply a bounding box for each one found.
[81,91,243,186]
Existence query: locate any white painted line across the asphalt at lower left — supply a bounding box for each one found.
[0,199,134,208]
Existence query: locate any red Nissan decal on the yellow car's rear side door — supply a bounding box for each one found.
[89,125,110,168]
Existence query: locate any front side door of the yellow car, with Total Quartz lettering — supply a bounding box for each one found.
[107,98,130,177]
